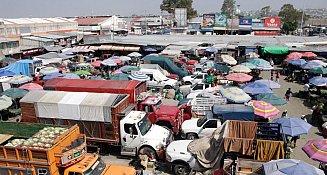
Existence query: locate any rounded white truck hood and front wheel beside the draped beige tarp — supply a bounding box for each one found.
[166,140,196,175]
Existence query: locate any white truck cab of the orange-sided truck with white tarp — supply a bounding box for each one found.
[120,111,173,159]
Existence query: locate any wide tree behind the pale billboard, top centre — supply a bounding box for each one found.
[160,0,198,19]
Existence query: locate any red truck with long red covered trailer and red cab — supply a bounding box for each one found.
[43,78,183,134]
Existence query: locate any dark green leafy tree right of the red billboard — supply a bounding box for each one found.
[278,4,308,34]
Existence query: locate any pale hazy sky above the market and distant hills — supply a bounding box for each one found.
[0,0,327,18]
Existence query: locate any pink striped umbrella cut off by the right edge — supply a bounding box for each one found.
[302,139,327,163]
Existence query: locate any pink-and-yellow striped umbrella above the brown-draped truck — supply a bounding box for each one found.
[253,101,279,118]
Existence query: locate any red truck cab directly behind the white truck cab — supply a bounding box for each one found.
[138,96,184,134]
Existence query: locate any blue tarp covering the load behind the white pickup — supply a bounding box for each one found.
[212,104,254,122]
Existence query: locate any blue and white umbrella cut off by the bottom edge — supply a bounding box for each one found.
[262,159,324,175]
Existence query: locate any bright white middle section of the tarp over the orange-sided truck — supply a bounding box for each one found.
[58,92,87,120]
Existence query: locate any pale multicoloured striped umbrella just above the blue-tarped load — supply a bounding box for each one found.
[220,87,251,103]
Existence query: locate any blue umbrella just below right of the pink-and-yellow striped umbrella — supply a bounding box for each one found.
[271,117,311,137]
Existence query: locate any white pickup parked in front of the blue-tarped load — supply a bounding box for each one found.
[182,114,222,140]
